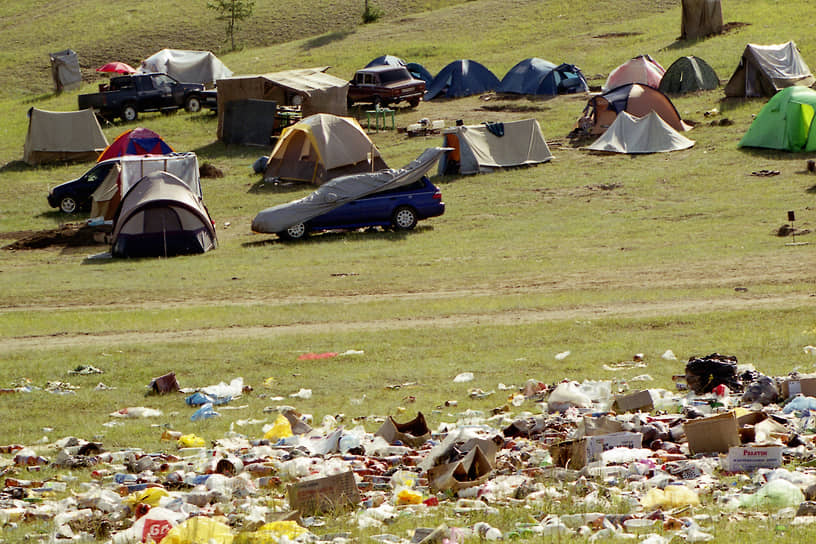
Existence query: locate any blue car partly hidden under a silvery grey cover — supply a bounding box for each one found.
[277,176,445,240]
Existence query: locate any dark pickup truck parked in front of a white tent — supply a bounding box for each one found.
[77,73,217,121]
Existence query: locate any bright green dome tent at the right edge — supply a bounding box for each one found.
[737,86,816,151]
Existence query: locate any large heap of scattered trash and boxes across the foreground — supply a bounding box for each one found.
[0,353,816,544]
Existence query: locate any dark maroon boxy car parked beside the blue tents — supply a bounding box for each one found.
[348,66,425,107]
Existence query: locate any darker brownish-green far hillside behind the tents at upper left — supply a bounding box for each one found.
[0,0,461,96]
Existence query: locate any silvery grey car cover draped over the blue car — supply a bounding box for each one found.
[252,147,446,234]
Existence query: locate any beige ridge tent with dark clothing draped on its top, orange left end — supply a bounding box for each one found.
[439,119,552,174]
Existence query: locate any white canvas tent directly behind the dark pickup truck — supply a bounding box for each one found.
[139,49,232,86]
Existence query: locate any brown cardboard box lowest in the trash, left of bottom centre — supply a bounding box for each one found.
[289,470,361,516]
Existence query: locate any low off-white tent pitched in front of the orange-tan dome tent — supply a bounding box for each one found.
[587,111,694,154]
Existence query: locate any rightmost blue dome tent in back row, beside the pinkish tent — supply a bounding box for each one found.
[498,57,589,95]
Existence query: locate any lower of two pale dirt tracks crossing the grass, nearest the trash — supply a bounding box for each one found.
[3,293,816,353]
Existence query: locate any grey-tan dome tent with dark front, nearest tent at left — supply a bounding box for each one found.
[111,171,218,257]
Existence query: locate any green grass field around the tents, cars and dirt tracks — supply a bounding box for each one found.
[0,0,816,542]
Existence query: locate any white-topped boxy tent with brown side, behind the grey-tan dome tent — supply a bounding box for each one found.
[91,152,202,219]
